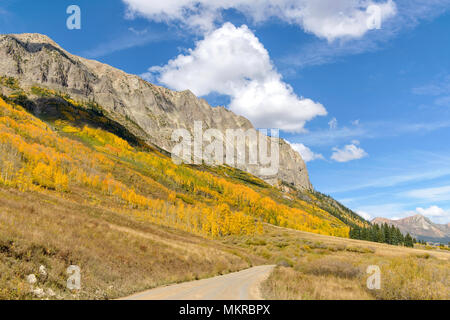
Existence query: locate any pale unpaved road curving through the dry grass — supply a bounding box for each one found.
[123,266,275,300]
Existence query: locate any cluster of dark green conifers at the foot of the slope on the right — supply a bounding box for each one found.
[349,223,417,248]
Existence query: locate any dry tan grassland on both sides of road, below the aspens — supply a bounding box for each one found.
[0,188,450,299]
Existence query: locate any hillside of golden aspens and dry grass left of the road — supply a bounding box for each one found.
[0,91,360,298]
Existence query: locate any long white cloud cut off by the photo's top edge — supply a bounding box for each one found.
[123,0,397,41]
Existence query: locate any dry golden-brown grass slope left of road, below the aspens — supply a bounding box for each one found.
[0,188,262,299]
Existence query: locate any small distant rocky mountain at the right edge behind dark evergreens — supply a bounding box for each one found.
[372,214,450,243]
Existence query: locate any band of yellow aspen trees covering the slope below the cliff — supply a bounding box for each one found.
[0,97,349,237]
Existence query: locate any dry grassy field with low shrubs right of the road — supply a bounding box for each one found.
[252,228,450,300]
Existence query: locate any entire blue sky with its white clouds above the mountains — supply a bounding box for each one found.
[0,0,450,223]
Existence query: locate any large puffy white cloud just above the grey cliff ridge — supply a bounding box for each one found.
[146,23,327,132]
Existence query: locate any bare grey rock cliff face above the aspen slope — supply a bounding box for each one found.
[0,34,312,189]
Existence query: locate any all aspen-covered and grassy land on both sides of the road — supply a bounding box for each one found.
[0,87,450,299]
